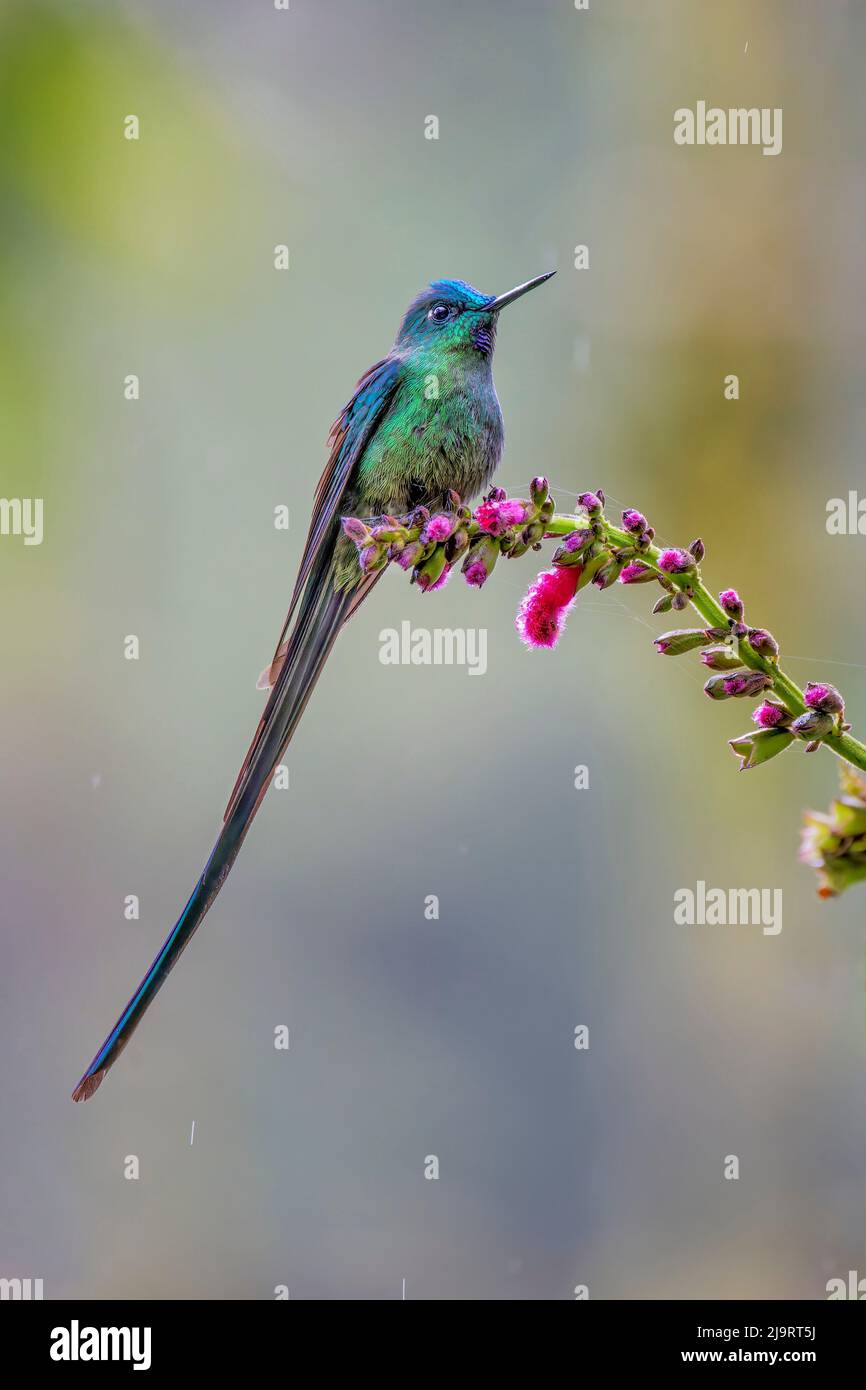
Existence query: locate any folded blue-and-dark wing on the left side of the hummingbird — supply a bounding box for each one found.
[265,357,402,660]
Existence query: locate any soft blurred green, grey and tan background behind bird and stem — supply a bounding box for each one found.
[0,0,866,1300]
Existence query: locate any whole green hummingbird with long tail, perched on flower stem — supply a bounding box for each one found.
[72,271,555,1101]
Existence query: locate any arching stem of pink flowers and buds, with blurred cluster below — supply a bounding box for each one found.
[342,477,866,898]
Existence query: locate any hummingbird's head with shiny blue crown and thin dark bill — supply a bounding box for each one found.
[395,270,556,357]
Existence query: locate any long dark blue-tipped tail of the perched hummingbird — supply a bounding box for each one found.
[72,564,360,1101]
